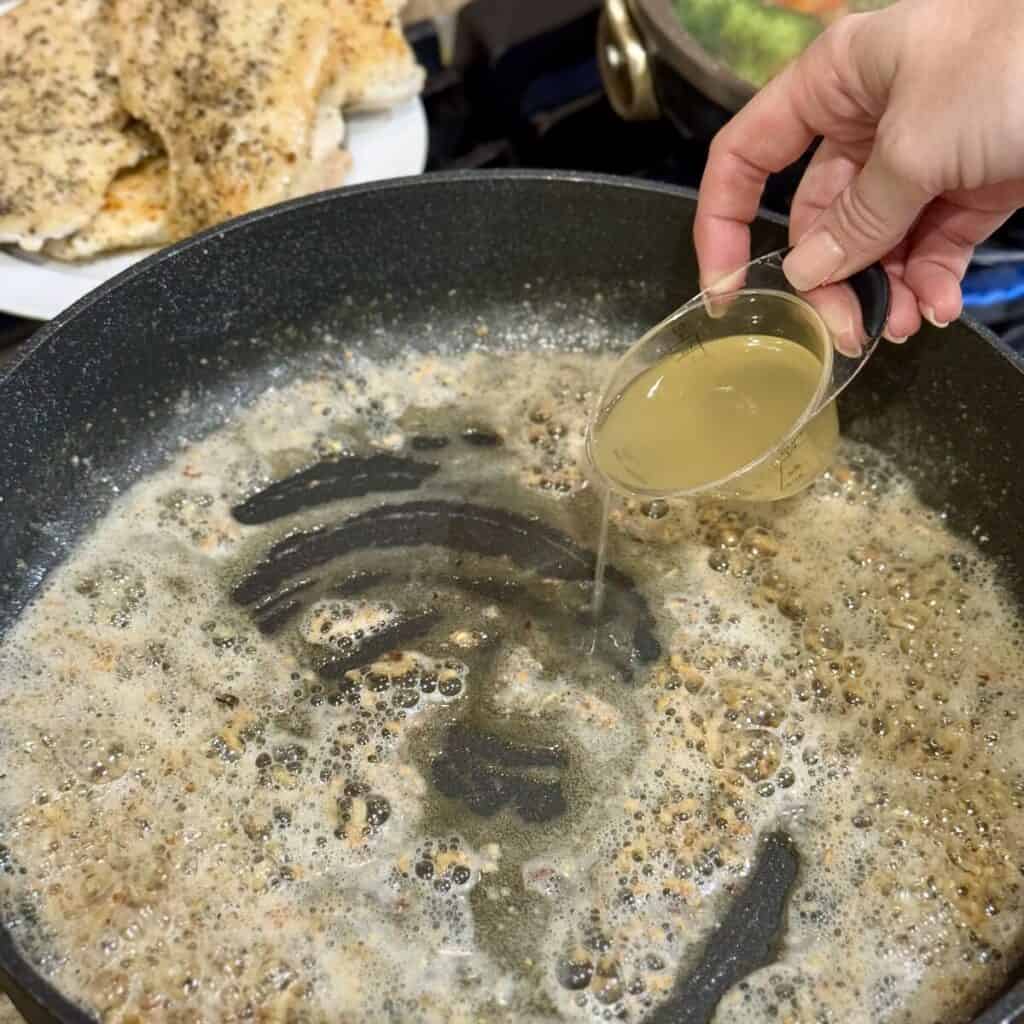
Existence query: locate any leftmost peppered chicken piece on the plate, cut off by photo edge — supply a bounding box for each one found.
[0,0,148,251]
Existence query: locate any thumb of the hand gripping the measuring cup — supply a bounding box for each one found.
[782,144,931,292]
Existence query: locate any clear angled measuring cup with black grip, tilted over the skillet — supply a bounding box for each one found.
[587,250,890,501]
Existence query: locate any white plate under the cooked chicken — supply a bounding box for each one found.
[0,96,427,319]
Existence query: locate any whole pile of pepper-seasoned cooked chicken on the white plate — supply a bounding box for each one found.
[0,0,423,259]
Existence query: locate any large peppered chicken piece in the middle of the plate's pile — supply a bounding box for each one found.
[116,0,358,238]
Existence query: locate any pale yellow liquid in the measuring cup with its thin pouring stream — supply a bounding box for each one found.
[591,334,838,629]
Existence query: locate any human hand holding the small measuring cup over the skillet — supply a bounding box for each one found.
[694,0,1024,341]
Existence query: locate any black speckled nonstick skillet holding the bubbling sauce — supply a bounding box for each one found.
[0,172,1024,1024]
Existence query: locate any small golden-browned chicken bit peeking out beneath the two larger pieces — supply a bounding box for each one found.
[44,157,173,260]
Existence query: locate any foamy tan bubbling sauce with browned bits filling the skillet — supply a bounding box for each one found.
[0,351,1024,1022]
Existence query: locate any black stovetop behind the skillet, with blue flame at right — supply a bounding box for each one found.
[6,0,1024,356]
